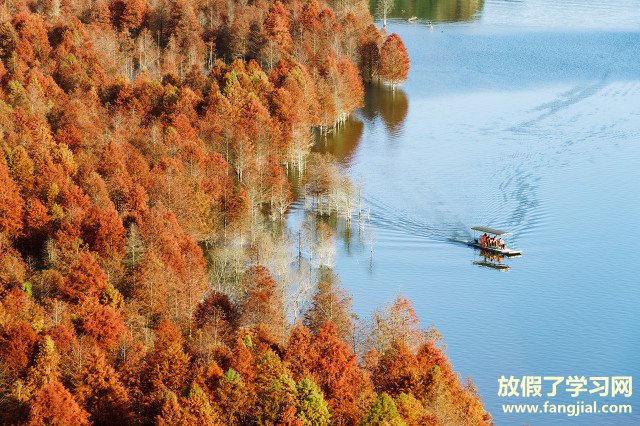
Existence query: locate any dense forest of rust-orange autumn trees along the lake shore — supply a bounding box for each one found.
[0,0,490,425]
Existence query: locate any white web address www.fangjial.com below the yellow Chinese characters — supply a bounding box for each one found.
[502,401,633,417]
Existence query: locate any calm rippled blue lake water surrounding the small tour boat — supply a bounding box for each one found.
[300,0,640,425]
